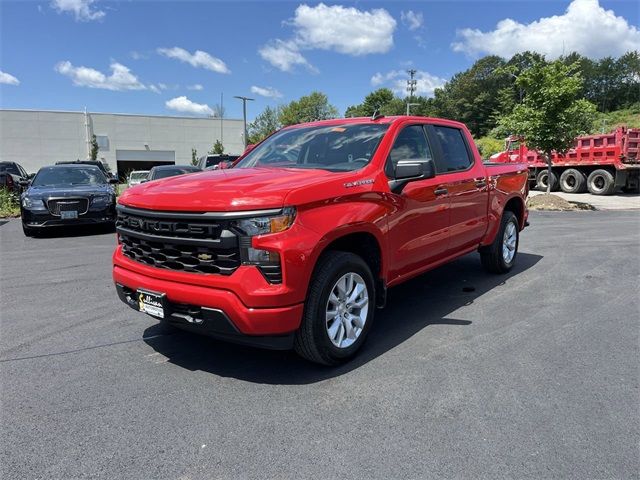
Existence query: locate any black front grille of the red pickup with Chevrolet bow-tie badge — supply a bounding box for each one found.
[116,207,241,275]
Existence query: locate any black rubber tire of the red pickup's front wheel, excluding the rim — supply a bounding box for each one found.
[294,251,376,365]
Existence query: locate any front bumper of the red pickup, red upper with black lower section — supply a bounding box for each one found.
[113,264,303,349]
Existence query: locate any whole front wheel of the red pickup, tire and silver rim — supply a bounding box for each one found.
[294,251,375,365]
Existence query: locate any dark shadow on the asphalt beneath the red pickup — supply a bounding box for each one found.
[144,252,542,385]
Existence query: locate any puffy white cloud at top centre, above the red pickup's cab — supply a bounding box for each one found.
[291,3,396,55]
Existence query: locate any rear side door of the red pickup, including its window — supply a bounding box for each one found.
[427,125,489,255]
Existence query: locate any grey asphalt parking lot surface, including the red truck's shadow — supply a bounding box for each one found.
[0,211,640,480]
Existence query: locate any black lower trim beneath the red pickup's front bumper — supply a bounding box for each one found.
[116,283,294,350]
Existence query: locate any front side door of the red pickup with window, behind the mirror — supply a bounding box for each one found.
[385,125,449,281]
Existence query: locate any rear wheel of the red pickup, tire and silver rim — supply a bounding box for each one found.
[480,211,520,273]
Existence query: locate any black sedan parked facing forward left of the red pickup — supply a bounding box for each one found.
[20,165,117,237]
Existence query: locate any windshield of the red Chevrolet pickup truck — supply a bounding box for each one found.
[234,123,389,172]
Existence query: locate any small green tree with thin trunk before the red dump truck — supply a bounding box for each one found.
[501,60,596,193]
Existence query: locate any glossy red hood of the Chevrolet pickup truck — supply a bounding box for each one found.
[119,168,343,212]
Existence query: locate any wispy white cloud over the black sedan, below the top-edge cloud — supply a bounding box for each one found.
[55,61,147,91]
